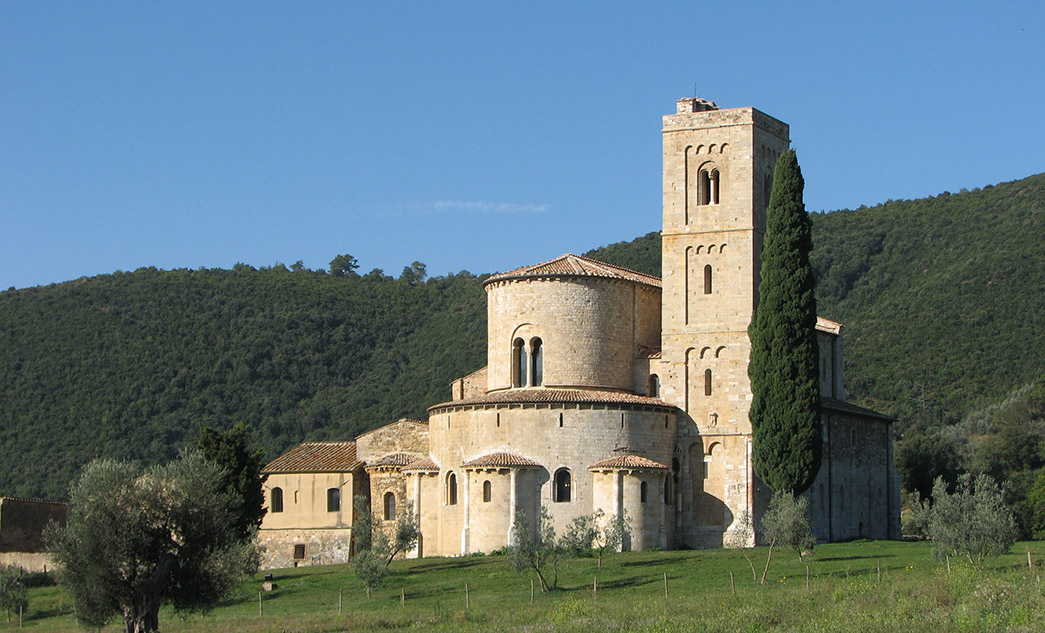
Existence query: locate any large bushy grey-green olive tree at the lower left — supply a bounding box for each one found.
[47,452,258,633]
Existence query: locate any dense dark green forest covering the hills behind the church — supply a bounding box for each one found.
[0,170,1045,505]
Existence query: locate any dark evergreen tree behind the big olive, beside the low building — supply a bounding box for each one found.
[196,422,265,538]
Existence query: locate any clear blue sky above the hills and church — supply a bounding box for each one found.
[0,0,1045,288]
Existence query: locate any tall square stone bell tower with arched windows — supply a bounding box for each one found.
[660,97,790,546]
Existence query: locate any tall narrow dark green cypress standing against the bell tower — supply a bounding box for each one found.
[747,149,822,495]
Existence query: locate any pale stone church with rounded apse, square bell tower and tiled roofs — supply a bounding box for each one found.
[254,98,900,566]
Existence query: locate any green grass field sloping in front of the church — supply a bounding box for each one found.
[8,541,1045,633]
